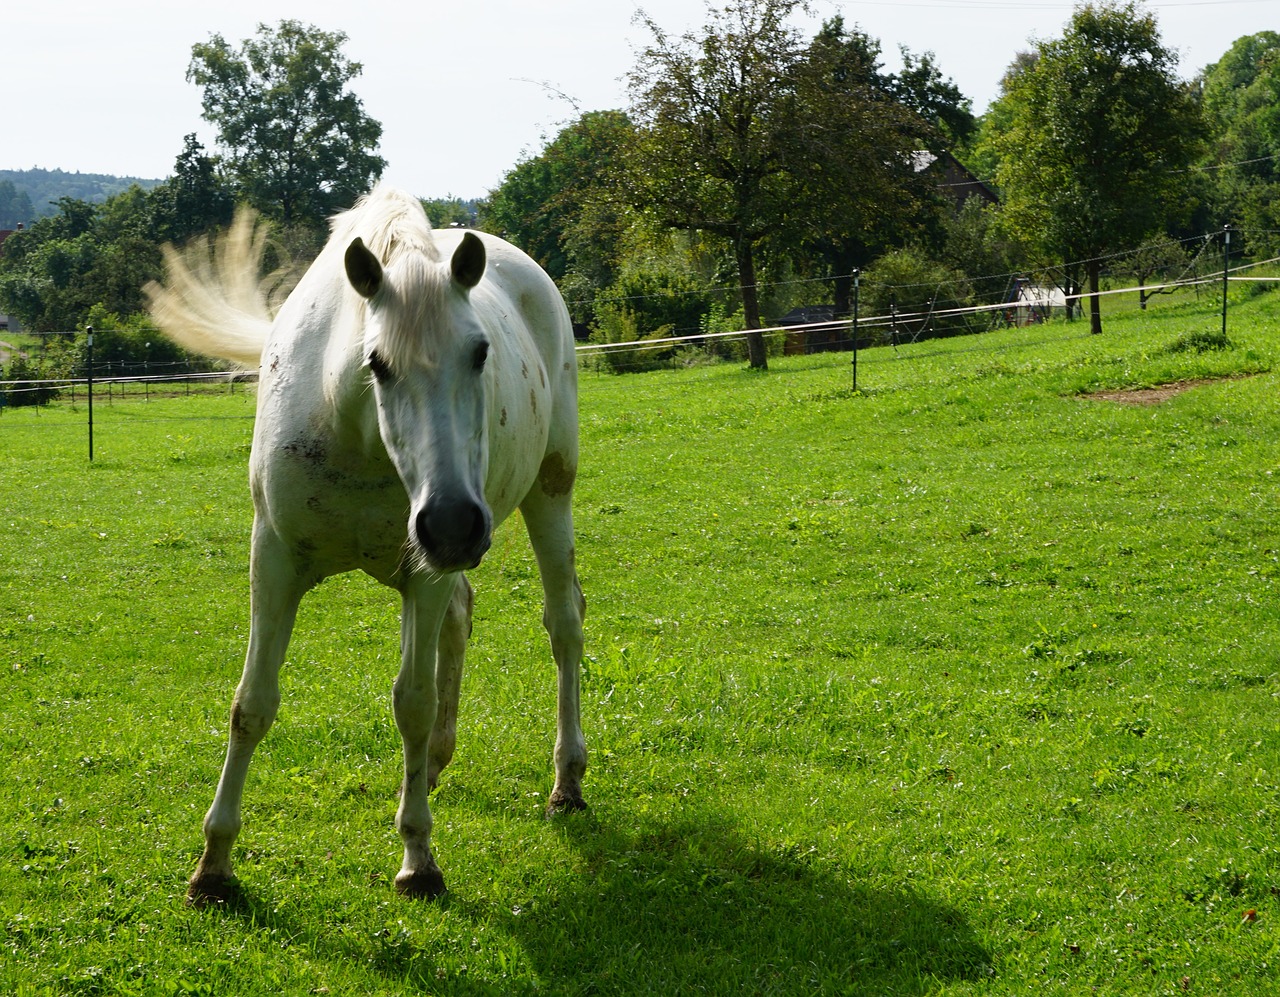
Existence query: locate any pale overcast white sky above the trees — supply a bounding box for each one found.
[0,0,1280,197]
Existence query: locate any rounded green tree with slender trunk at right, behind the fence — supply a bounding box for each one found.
[998,0,1203,333]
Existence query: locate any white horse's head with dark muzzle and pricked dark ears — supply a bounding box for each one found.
[346,232,493,572]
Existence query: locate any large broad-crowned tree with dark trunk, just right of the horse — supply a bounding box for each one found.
[630,0,946,369]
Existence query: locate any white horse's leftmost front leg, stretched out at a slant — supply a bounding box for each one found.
[187,521,307,906]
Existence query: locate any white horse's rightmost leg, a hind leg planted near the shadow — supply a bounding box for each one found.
[520,484,586,814]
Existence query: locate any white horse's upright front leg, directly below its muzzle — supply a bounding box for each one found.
[394,575,457,897]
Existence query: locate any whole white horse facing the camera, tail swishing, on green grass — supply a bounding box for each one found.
[148,187,586,904]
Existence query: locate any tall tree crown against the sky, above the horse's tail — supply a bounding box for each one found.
[187,20,387,224]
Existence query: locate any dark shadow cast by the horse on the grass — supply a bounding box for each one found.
[499,814,991,994]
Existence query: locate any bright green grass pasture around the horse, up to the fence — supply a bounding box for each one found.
[0,286,1280,997]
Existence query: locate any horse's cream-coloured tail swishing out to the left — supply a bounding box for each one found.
[145,209,284,367]
